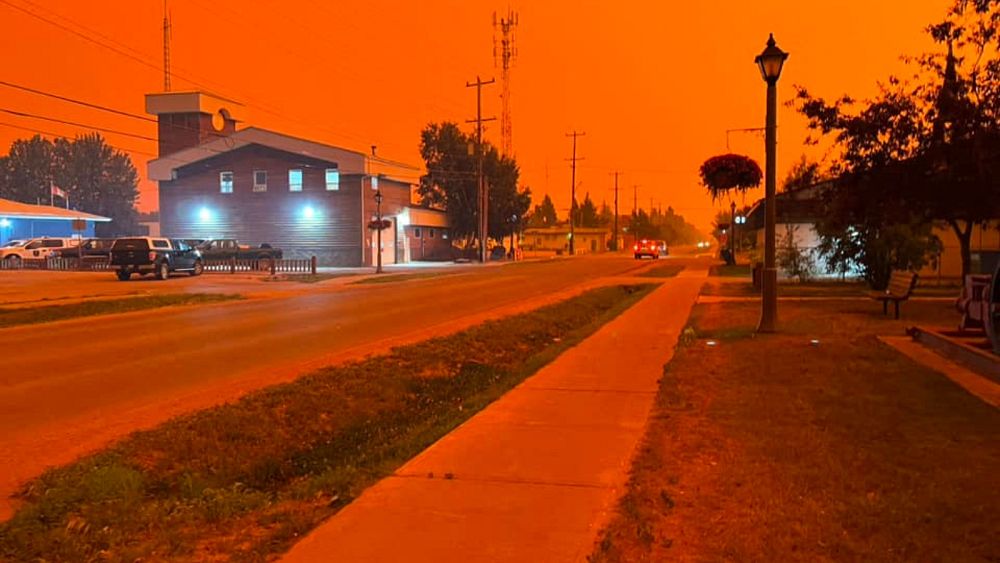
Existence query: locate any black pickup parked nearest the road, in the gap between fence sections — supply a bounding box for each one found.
[111,237,204,281]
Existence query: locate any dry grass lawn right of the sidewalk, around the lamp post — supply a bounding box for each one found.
[592,301,1000,562]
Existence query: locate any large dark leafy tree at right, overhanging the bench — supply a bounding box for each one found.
[796,0,1000,285]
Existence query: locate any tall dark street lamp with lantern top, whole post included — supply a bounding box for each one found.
[754,34,788,332]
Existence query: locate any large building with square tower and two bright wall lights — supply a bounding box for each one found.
[146,92,446,266]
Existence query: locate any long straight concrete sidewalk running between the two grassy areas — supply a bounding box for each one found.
[283,270,707,563]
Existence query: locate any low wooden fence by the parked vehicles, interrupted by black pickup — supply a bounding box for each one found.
[0,256,317,275]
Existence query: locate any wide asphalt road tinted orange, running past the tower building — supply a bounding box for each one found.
[0,256,662,519]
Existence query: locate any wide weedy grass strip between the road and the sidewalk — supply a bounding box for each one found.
[0,284,655,561]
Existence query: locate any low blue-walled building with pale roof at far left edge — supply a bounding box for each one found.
[0,199,111,244]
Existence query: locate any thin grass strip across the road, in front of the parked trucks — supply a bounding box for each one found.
[0,293,243,328]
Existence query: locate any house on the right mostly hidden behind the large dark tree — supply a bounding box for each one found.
[738,181,1000,279]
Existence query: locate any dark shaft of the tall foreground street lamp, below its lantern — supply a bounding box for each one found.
[757,79,778,332]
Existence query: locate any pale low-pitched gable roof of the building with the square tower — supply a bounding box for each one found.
[147,127,422,183]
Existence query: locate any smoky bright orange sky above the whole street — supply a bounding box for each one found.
[0,0,950,228]
